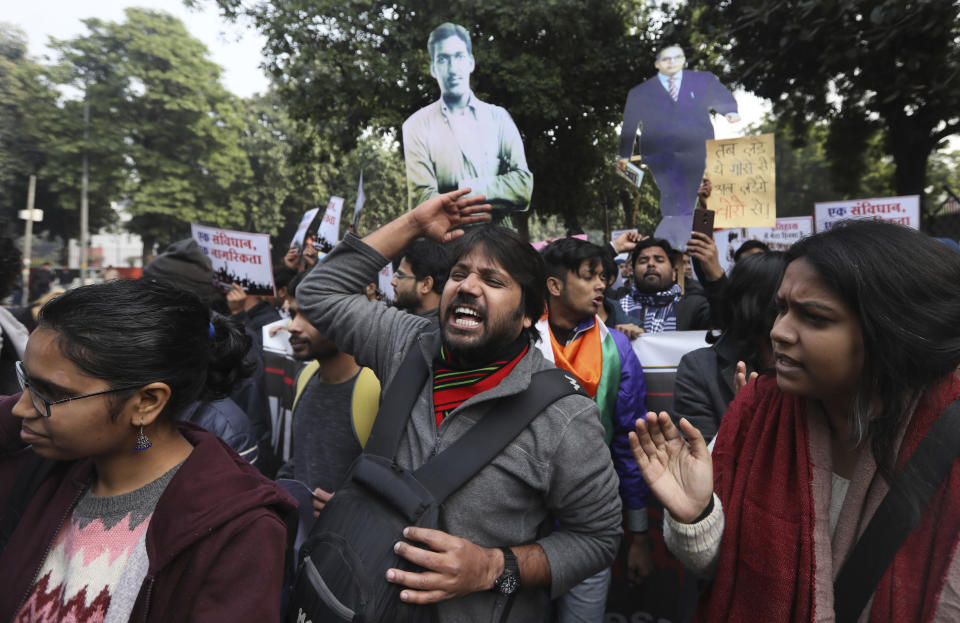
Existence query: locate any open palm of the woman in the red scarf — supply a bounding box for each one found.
[630,411,713,523]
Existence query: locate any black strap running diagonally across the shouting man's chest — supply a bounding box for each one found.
[413,368,589,503]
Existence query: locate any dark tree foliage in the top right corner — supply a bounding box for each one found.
[690,0,960,202]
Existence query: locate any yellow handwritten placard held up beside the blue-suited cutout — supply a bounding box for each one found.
[705,134,777,229]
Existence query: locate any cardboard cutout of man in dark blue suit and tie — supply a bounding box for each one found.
[619,45,740,248]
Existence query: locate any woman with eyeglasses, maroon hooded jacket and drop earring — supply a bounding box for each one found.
[0,280,295,622]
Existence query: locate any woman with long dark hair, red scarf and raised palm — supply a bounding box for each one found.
[631,221,960,623]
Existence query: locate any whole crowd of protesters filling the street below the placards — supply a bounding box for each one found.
[0,186,960,623]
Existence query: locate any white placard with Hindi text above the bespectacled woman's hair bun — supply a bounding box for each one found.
[190,223,276,296]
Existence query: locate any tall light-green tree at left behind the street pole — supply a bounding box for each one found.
[44,9,257,251]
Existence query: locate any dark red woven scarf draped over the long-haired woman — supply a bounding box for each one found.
[696,374,960,623]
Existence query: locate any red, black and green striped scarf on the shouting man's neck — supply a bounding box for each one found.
[433,342,530,426]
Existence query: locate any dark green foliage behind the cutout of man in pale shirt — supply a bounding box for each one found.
[202,0,657,233]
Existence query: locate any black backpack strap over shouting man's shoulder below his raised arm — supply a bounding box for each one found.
[363,340,430,460]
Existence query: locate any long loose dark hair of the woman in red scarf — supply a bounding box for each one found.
[786,221,960,478]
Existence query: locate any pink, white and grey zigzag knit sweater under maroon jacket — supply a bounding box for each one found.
[14,465,180,623]
